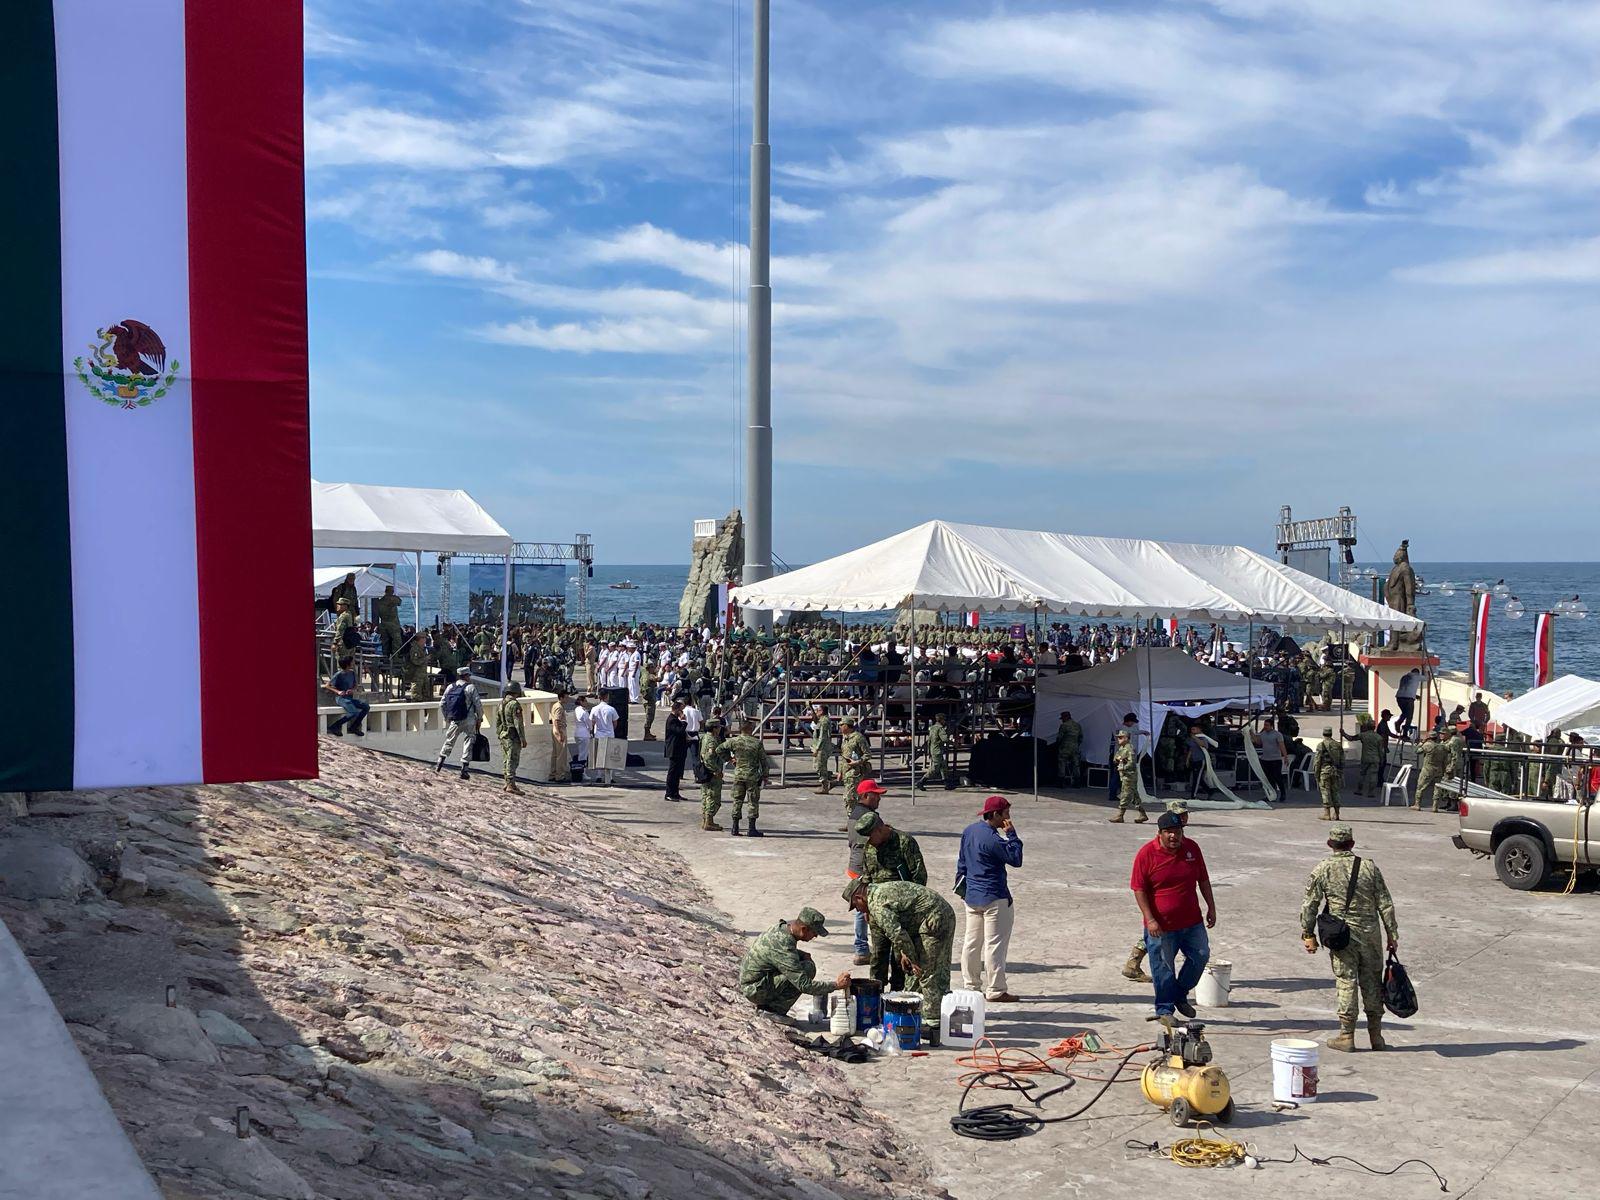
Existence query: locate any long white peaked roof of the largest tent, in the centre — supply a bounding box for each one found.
[734,522,1422,630]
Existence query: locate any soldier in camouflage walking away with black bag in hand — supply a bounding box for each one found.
[1301,822,1400,1051]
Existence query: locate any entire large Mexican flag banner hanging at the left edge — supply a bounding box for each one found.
[0,0,317,792]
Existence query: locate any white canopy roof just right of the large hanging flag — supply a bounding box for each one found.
[310,480,512,554]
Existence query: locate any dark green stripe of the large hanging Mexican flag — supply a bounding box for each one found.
[0,0,74,792]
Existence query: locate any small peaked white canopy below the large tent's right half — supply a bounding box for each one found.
[1034,646,1272,763]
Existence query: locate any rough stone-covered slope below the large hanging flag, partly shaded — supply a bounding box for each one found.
[0,739,942,1200]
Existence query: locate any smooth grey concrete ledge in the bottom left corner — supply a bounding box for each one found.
[0,922,162,1200]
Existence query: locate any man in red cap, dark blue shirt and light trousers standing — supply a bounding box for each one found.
[955,795,1022,1003]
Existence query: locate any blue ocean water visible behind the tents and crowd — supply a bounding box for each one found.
[384,558,1600,691]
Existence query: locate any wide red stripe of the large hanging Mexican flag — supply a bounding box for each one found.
[184,0,317,782]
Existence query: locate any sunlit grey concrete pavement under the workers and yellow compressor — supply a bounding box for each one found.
[565,742,1600,1200]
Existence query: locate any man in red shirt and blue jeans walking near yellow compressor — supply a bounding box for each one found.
[1131,813,1216,1026]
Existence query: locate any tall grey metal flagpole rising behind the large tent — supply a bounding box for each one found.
[741,0,773,632]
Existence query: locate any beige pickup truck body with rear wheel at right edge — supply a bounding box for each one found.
[1450,795,1600,891]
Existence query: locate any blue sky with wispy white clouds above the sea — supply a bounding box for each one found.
[306,0,1600,562]
